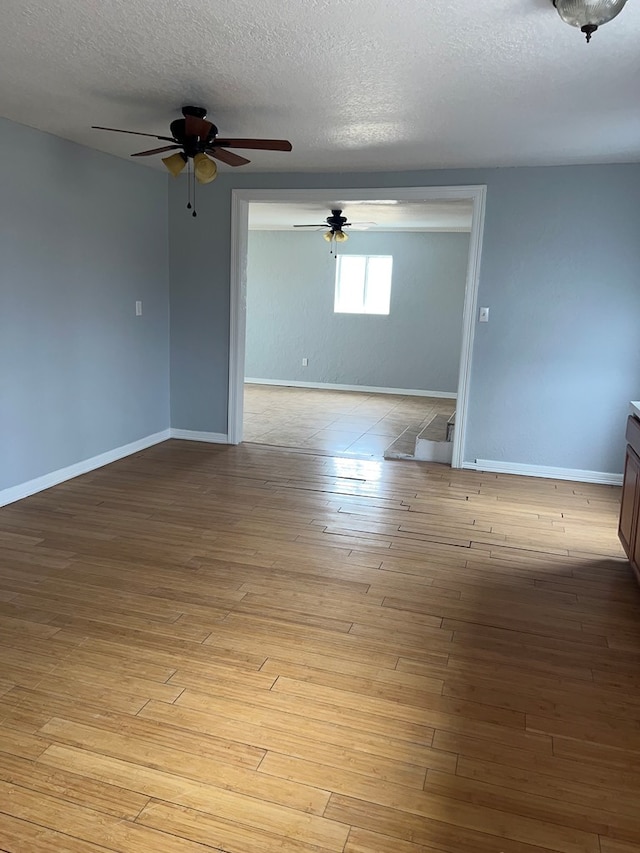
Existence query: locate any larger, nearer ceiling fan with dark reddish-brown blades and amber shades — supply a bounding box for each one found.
[92,106,293,216]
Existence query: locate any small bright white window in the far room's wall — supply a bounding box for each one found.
[333,255,393,314]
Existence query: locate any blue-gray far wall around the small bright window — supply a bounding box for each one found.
[245,231,469,392]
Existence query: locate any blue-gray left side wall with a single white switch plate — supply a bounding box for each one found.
[0,120,169,490]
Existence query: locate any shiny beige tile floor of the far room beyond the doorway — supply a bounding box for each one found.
[244,383,455,458]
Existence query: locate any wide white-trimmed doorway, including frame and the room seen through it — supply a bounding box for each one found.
[228,187,485,467]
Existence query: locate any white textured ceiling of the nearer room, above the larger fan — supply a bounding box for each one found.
[0,0,640,171]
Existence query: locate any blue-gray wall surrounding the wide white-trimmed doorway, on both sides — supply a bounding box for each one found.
[169,164,640,472]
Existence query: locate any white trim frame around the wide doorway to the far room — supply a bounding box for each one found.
[228,187,485,467]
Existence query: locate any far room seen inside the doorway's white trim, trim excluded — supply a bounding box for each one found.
[243,200,472,461]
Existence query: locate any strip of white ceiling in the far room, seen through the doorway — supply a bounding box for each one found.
[249,198,473,228]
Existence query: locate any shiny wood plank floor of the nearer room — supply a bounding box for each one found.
[0,441,640,853]
